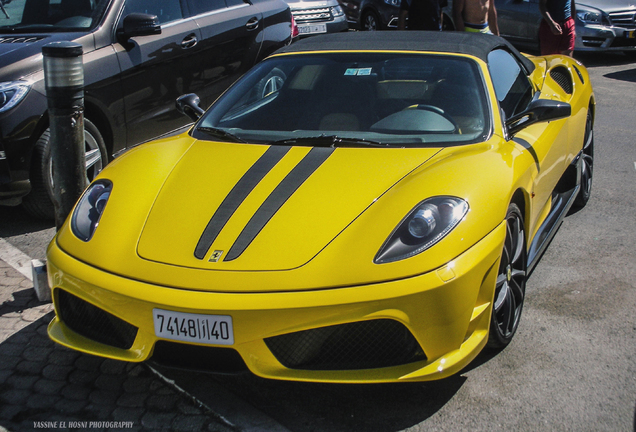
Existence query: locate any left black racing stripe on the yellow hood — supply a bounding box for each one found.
[194,146,291,259]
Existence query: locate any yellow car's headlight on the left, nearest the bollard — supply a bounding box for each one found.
[71,180,113,241]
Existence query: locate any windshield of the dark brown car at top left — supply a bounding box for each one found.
[0,0,109,33]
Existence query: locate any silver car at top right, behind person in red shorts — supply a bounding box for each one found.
[495,0,636,52]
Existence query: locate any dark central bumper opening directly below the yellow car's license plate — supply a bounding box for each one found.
[150,340,247,373]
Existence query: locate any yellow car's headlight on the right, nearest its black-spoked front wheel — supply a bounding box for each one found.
[374,196,468,264]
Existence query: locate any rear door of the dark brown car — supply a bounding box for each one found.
[188,0,263,108]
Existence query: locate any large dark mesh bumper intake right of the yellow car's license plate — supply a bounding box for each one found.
[265,319,426,370]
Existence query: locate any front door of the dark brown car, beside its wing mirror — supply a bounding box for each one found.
[116,0,203,145]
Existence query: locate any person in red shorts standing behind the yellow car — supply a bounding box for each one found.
[539,0,576,56]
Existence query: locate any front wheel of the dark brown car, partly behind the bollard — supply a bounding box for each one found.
[22,119,108,220]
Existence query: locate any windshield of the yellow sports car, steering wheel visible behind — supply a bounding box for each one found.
[199,53,490,147]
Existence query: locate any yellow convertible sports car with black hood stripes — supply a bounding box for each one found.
[48,31,595,382]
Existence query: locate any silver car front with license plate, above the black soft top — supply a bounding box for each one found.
[286,0,349,37]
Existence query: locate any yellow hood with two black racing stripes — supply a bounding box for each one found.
[137,141,439,271]
